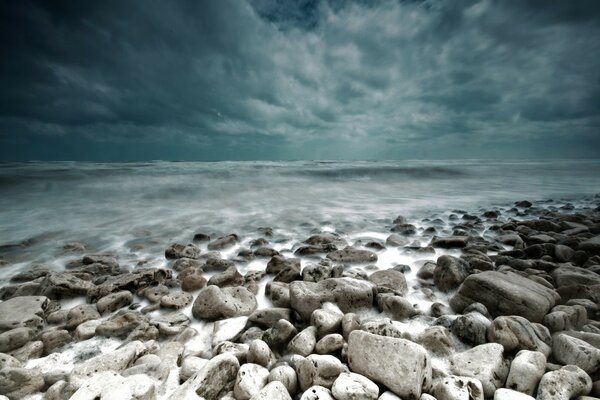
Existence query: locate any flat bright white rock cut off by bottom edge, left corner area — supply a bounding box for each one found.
[70,371,156,400]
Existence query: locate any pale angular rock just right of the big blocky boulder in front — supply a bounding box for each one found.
[450,343,508,397]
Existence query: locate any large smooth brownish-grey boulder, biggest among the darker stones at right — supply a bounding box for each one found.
[450,271,559,322]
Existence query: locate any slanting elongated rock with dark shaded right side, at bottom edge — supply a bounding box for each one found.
[170,354,240,400]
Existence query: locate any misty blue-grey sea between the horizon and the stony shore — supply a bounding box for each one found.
[0,160,600,279]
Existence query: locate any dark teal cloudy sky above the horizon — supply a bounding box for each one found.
[0,0,600,161]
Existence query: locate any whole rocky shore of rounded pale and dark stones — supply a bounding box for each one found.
[0,201,600,400]
